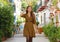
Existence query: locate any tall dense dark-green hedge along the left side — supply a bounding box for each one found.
[0,4,14,37]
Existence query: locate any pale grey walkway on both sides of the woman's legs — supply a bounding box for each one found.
[4,34,49,42]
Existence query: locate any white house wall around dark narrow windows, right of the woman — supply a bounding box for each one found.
[38,9,50,24]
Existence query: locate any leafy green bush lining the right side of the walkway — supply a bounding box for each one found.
[43,23,58,42]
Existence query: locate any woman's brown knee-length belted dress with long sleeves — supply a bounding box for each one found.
[21,14,36,37]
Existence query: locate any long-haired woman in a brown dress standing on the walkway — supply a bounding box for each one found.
[20,6,37,42]
